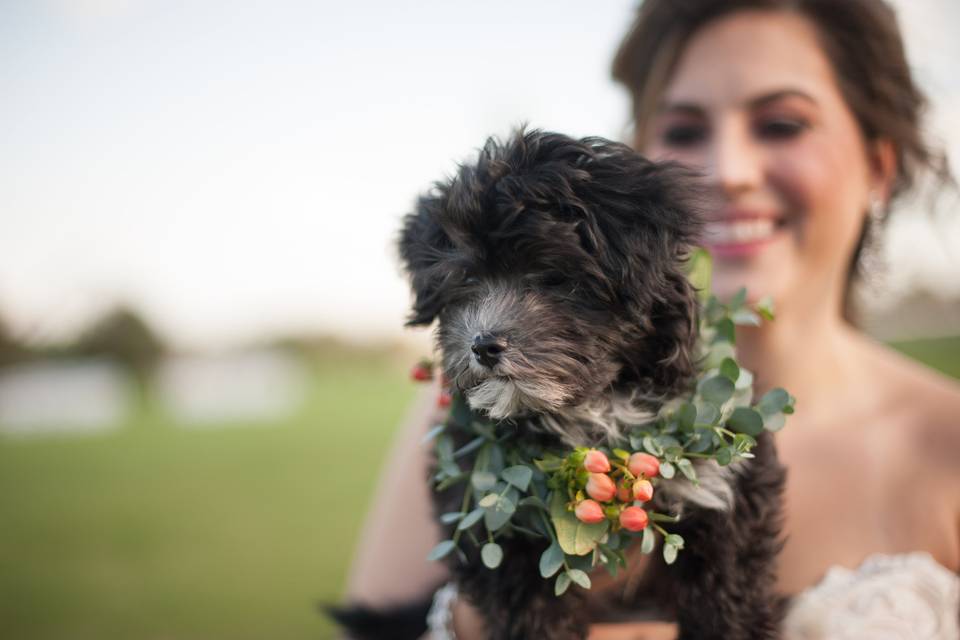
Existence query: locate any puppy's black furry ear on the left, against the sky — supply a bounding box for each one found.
[399,192,453,327]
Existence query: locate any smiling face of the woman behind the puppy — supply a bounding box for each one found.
[643,11,882,313]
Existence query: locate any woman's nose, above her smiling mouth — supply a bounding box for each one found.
[705,121,763,197]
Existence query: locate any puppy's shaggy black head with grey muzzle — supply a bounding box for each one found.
[400,131,698,419]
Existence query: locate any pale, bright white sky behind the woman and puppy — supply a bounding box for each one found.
[0,0,960,348]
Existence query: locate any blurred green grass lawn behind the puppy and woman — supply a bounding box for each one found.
[0,338,960,640]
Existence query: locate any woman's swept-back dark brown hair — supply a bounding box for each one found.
[613,0,952,319]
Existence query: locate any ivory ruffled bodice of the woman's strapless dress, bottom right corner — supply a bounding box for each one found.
[783,551,960,640]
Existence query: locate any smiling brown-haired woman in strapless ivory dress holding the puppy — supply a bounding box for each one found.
[350,0,960,640]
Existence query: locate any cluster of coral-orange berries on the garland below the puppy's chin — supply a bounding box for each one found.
[574,449,660,531]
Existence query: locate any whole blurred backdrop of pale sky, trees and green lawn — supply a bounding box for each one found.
[0,0,960,640]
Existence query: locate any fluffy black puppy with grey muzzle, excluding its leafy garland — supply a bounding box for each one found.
[326,131,784,640]
